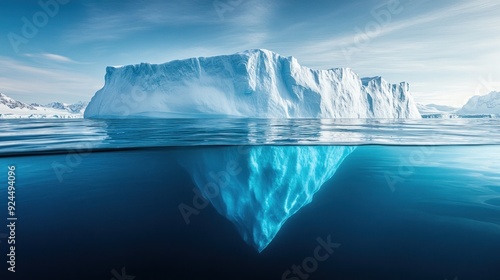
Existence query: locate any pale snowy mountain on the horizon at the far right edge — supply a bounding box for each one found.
[457,91,500,115]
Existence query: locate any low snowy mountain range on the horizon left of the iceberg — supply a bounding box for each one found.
[0,93,87,119]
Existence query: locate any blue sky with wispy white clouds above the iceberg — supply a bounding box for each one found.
[0,0,500,107]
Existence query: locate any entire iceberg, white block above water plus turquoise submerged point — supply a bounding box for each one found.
[85,50,421,252]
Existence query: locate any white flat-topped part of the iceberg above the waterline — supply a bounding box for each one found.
[85,50,420,118]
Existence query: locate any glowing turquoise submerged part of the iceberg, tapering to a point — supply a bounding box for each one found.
[179,146,355,252]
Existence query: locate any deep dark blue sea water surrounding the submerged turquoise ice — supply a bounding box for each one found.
[0,119,500,280]
